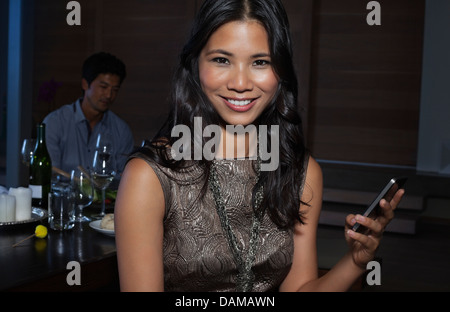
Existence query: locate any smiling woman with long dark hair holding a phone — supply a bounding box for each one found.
[115,0,403,291]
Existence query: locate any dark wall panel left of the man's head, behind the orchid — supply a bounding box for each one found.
[32,0,94,128]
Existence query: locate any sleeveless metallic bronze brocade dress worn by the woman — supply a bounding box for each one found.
[132,153,307,292]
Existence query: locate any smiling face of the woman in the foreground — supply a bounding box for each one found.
[199,20,278,126]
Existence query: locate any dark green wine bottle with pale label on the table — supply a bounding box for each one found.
[29,123,52,209]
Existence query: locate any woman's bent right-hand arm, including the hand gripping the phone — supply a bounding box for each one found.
[280,158,404,291]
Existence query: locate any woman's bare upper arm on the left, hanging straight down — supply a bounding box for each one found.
[114,159,165,291]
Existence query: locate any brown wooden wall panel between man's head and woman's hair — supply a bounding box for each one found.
[102,0,195,142]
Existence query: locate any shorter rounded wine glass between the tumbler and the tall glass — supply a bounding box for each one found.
[70,167,94,222]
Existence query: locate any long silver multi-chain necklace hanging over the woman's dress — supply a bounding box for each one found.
[209,157,264,292]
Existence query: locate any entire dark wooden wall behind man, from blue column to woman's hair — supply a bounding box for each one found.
[33,0,198,144]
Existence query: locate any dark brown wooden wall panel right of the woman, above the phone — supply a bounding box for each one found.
[308,0,424,166]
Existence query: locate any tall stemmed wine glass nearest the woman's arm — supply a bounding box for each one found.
[91,140,116,218]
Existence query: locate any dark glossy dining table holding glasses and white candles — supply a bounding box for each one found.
[0,205,120,292]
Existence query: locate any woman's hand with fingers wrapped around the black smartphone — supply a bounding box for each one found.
[345,189,405,269]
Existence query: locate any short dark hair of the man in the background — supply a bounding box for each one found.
[82,52,127,86]
